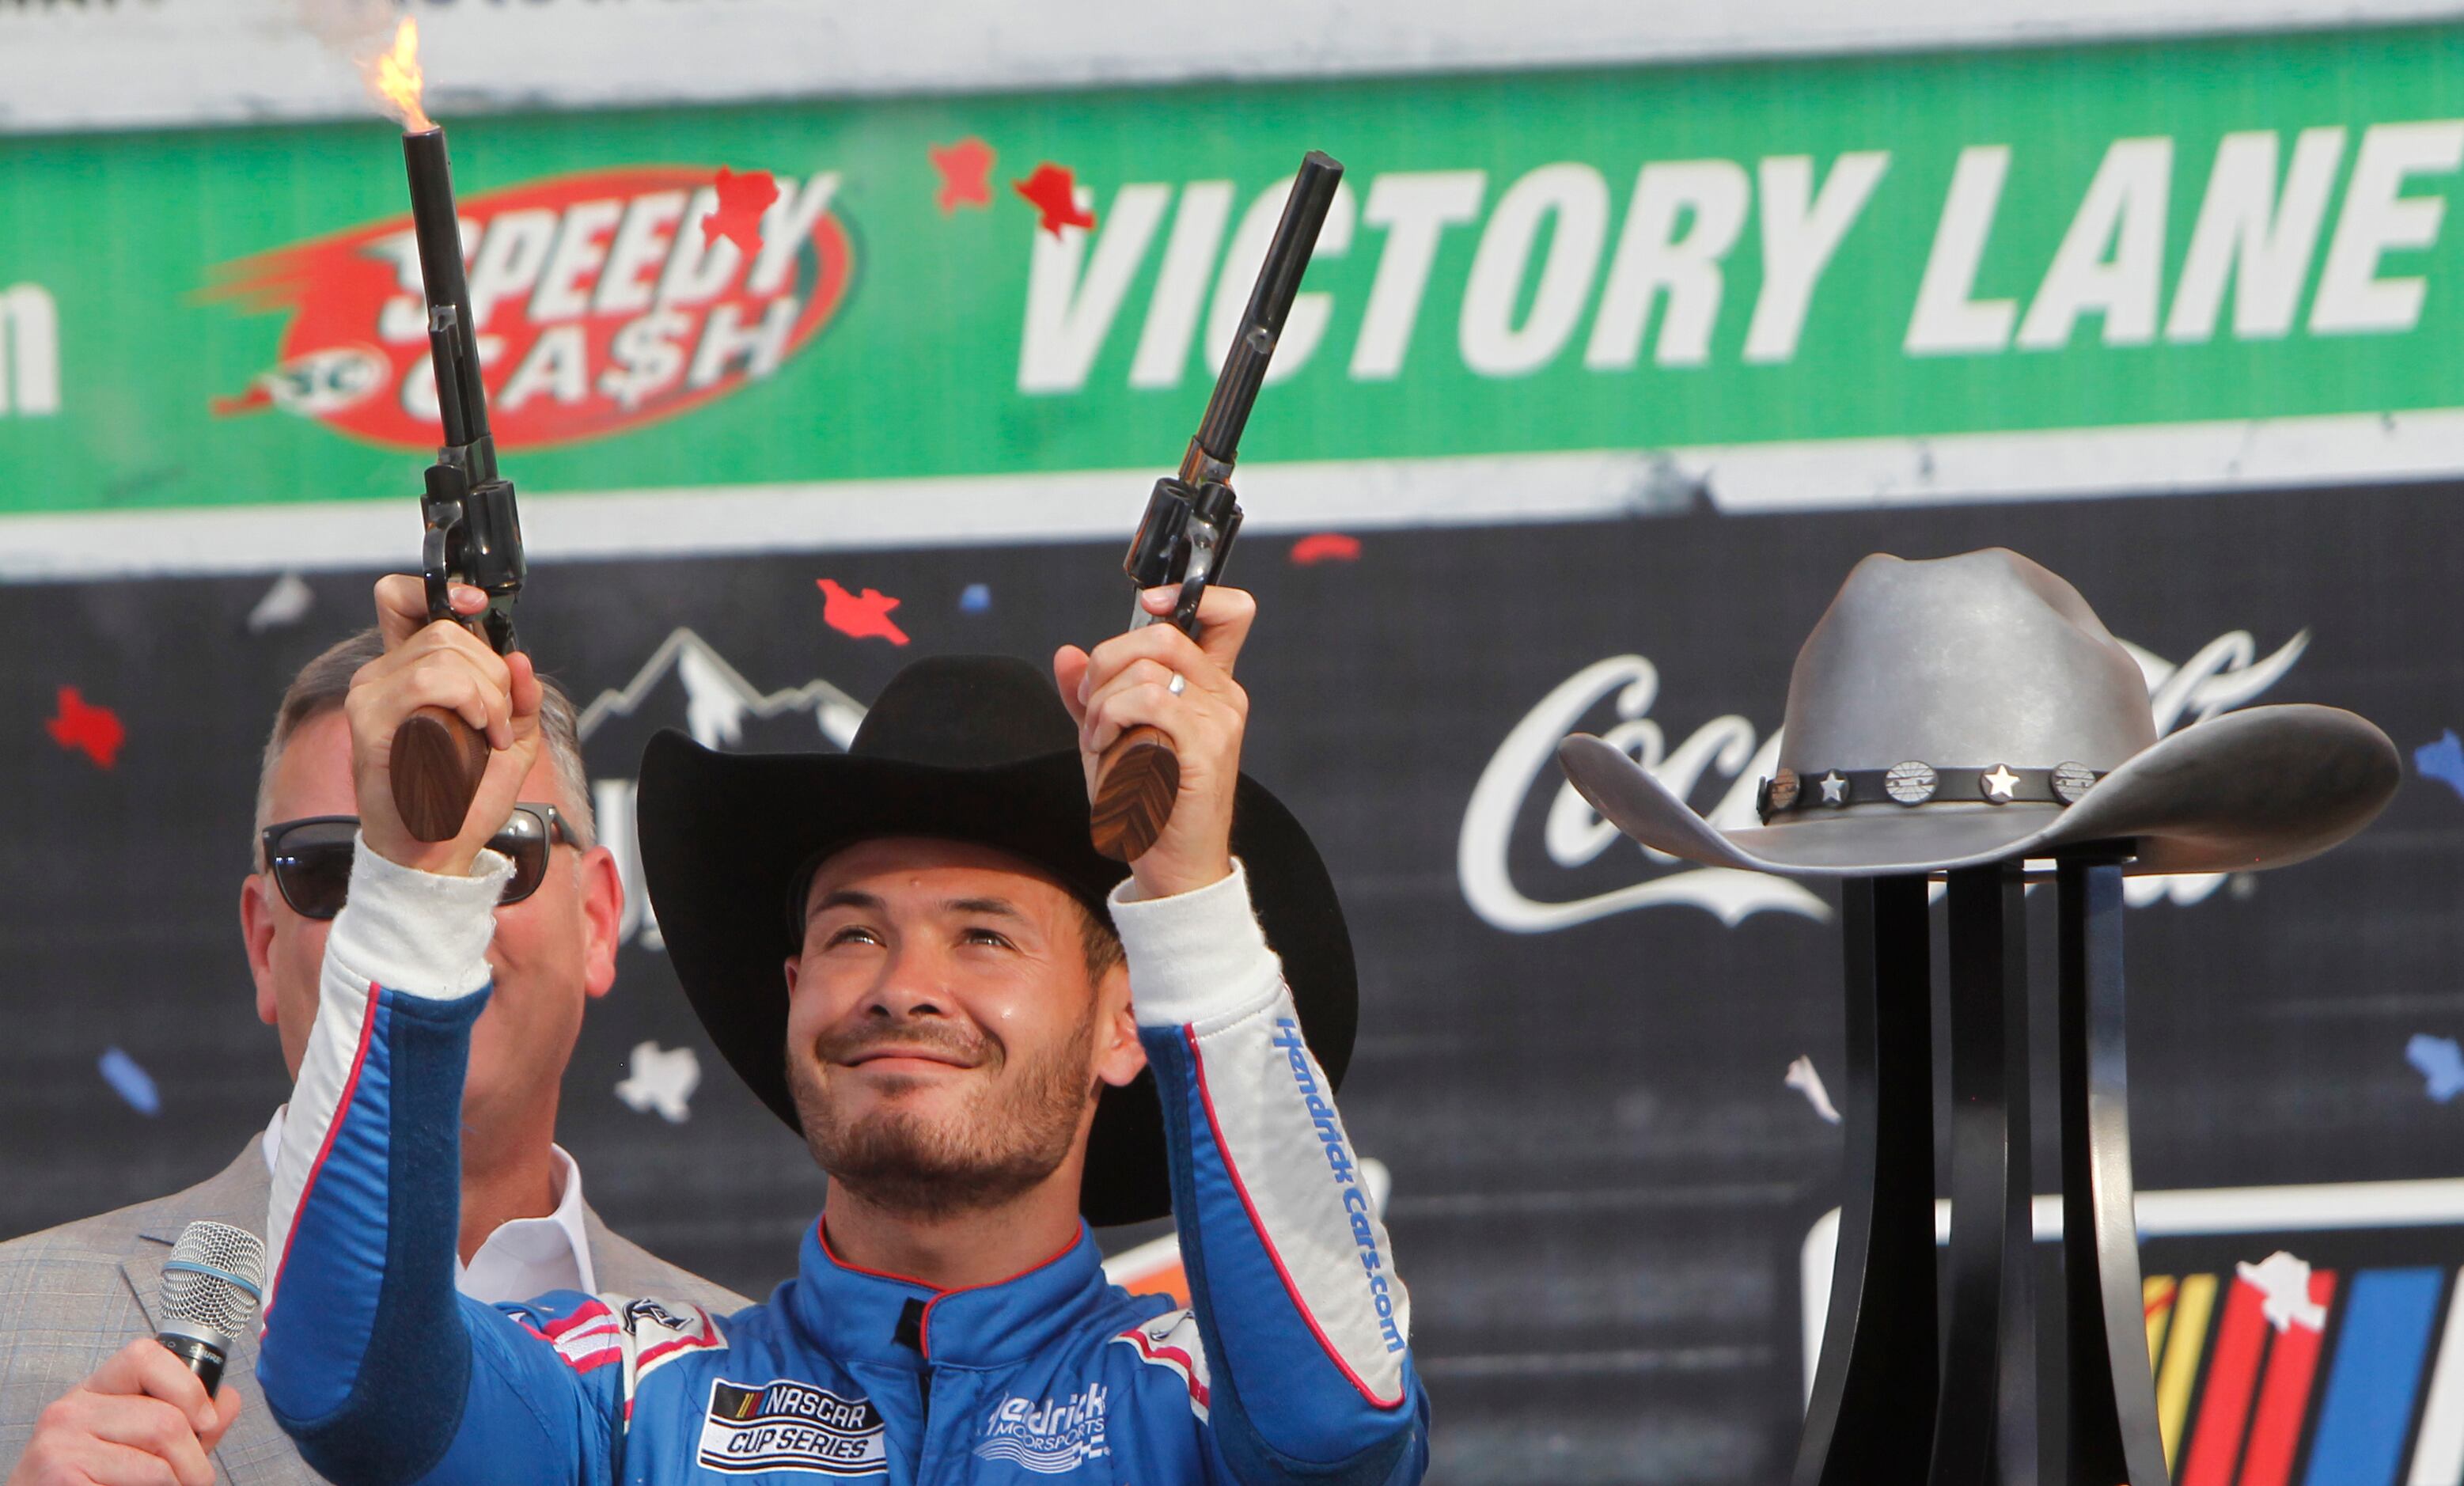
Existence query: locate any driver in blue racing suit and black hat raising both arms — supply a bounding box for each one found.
[259,577,1429,1486]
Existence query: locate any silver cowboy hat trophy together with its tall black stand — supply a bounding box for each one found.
[1557,550,2402,1486]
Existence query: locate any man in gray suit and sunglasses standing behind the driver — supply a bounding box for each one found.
[0,631,747,1486]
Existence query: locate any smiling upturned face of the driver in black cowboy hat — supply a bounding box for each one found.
[786,838,1146,1218]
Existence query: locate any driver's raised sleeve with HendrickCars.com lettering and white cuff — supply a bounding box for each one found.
[1111,862,1429,1486]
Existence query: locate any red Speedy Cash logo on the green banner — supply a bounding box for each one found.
[207,165,855,449]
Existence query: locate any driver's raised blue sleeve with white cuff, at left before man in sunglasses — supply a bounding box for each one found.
[256,845,631,1484]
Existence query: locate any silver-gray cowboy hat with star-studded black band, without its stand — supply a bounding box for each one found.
[1557,547,2402,878]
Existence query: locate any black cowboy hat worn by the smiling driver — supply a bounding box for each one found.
[635,655,1360,1225]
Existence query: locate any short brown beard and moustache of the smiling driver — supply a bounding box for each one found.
[786,1003,1101,1220]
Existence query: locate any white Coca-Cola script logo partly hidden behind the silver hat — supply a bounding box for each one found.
[1456,628,2309,934]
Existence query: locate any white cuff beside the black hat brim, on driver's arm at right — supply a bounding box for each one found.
[1106,858,1283,1028]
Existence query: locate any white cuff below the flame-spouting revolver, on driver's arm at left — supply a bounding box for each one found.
[325,838,513,1000]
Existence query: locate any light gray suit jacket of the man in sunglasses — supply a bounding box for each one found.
[0,1139,752,1486]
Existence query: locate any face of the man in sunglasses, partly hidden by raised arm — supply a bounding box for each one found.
[239,710,624,1134]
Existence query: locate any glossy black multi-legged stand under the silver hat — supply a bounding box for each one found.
[1794,843,2168,1486]
